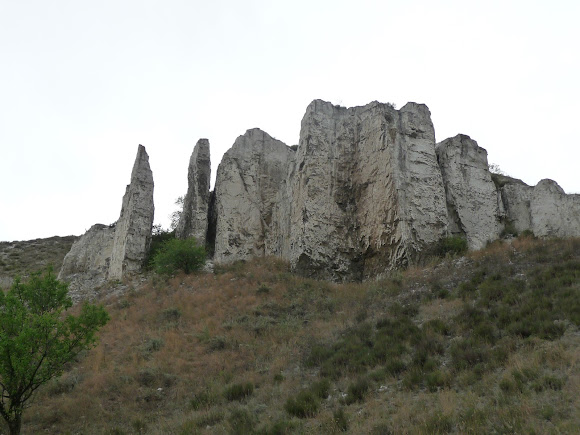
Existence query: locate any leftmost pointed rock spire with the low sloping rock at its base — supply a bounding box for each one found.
[58,145,154,300]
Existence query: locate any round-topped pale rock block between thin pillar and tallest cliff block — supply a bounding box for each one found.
[210,128,294,262]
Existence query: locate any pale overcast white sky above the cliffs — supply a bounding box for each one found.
[0,0,580,241]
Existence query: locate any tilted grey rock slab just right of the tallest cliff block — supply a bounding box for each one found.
[435,134,503,249]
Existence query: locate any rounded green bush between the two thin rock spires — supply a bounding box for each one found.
[153,238,205,275]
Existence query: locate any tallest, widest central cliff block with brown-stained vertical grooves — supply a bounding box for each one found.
[290,100,447,281]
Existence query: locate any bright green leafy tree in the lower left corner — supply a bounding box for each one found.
[0,268,109,434]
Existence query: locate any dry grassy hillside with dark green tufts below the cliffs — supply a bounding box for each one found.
[4,238,580,434]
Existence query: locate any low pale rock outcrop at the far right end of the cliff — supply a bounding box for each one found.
[501,179,580,237]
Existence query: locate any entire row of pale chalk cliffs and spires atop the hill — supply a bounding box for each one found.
[59,100,580,290]
